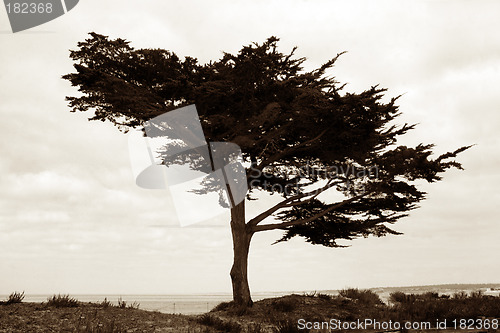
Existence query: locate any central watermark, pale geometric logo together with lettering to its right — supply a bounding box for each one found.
[129,105,378,226]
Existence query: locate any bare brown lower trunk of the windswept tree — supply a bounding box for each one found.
[231,200,253,308]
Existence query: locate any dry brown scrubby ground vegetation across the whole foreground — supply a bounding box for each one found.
[0,289,500,333]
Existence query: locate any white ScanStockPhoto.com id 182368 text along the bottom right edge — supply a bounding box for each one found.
[297,318,499,331]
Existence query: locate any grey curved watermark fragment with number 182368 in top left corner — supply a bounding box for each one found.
[4,0,79,33]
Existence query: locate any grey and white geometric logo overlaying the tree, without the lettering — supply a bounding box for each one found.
[129,105,248,226]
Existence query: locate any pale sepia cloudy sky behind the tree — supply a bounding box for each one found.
[0,0,500,294]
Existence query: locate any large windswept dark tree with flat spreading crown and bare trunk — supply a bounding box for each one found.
[63,33,469,307]
